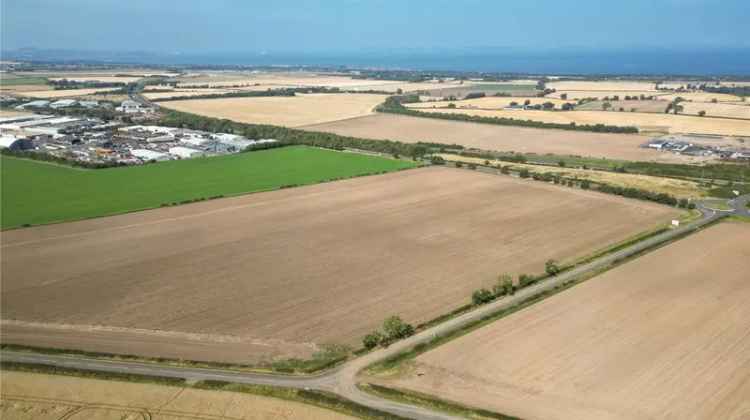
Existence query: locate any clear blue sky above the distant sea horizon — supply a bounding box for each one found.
[0,0,750,53]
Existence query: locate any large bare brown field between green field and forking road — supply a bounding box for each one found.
[2,167,679,362]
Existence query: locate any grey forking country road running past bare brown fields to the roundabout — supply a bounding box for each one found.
[0,194,750,420]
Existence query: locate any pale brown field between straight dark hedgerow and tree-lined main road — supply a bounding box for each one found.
[302,111,696,162]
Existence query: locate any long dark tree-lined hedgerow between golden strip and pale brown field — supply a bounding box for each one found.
[377,95,638,133]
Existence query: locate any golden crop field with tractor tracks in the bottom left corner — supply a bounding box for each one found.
[0,371,352,420]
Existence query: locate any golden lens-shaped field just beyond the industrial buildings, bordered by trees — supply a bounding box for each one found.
[162,93,386,127]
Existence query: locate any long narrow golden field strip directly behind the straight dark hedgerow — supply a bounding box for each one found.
[414,109,750,136]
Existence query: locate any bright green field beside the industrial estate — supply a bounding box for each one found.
[0,146,414,229]
